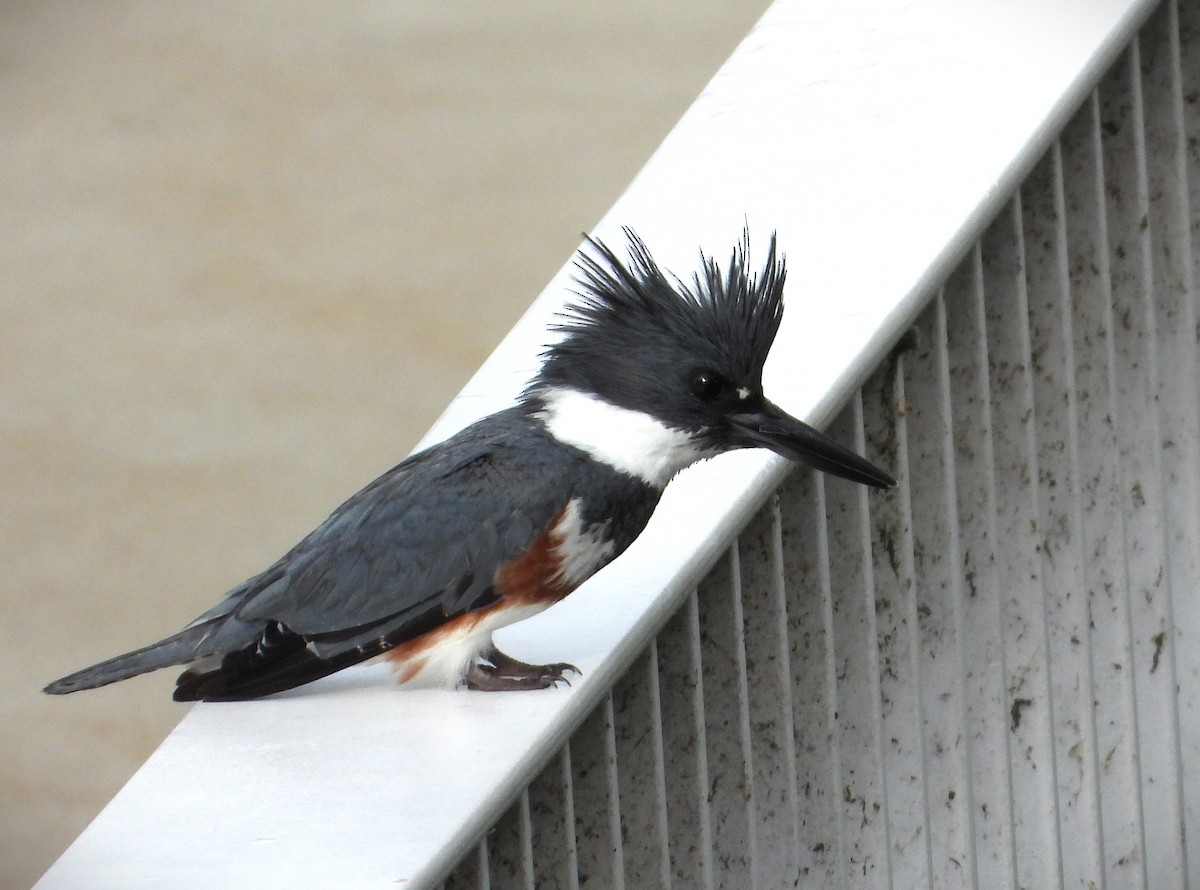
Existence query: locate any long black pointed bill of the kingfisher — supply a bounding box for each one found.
[730,401,896,488]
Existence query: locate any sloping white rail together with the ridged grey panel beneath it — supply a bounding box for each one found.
[38,0,1200,890]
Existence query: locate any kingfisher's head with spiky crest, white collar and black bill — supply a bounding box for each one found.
[526,229,895,488]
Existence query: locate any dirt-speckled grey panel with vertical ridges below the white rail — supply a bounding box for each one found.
[446,2,1200,888]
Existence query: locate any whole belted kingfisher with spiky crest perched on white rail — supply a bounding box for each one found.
[46,228,895,702]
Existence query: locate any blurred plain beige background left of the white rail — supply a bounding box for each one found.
[0,0,766,888]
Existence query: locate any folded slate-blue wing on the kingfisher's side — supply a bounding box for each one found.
[233,419,574,644]
